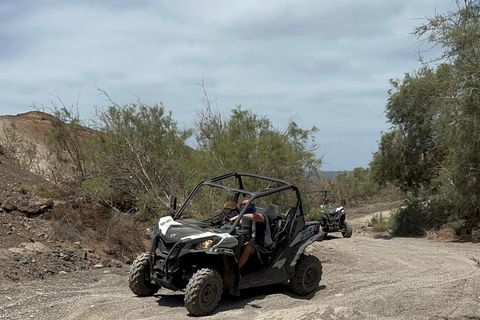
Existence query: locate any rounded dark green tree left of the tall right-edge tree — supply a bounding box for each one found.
[370,64,454,191]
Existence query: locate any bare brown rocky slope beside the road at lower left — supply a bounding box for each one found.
[0,152,125,282]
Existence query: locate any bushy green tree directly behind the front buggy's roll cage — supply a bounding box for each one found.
[195,90,321,182]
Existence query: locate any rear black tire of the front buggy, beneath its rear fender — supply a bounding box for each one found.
[290,255,322,296]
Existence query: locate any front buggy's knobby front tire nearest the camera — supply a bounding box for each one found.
[185,268,223,316]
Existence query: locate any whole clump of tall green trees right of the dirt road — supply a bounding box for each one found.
[370,0,480,241]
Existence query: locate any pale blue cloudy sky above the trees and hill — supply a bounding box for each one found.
[0,0,456,171]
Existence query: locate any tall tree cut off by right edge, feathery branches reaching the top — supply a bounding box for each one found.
[415,0,480,235]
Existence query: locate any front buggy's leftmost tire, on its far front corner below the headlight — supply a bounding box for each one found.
[128,252,160,297]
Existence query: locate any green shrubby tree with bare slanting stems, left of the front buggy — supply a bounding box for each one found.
[90,92,192,218]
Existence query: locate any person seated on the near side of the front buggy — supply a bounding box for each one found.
[230,199,273,268]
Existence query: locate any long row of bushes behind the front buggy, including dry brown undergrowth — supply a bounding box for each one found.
[17,85,403,254]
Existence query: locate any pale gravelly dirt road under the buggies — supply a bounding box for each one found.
[0,215,480,320]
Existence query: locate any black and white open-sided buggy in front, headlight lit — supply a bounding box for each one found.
[129,172,323,316]
